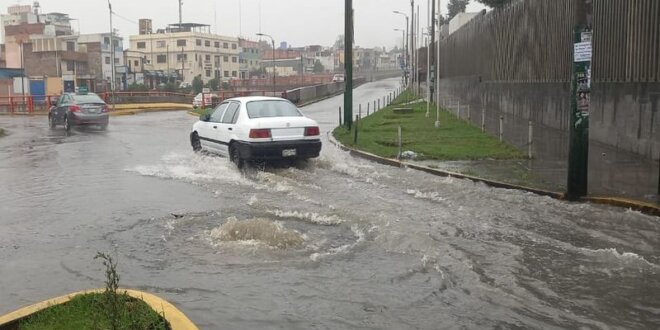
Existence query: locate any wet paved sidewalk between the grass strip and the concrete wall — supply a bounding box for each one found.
[413,87,660,205]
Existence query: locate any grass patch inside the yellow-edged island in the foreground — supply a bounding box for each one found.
[18,293,170,330]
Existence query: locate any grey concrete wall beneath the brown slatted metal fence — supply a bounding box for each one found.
[440,77,660,159]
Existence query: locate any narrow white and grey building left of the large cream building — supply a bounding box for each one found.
[78,33,127,92]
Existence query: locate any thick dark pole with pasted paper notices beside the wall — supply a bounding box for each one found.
[566,0,593,201]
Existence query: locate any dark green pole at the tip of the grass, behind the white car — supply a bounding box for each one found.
[344,0,353,130]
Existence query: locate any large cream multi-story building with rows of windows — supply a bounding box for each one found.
[129,23,240,82]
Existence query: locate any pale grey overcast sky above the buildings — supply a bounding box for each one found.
[0,0,484,49]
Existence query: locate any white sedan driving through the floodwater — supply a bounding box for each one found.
[190,96,321,168]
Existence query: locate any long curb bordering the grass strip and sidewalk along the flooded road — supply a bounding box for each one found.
[327,132,660,216]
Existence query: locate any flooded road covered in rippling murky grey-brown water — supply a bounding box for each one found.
[0,80,660,329]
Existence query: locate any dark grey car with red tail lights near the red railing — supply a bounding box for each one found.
[48,92,109,131]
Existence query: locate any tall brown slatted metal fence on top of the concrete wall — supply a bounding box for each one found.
[440,0,660,82]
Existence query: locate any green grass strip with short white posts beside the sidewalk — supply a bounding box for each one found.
[333,92,524,160]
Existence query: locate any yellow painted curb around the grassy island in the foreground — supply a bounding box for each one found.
[0,289,199,330]
